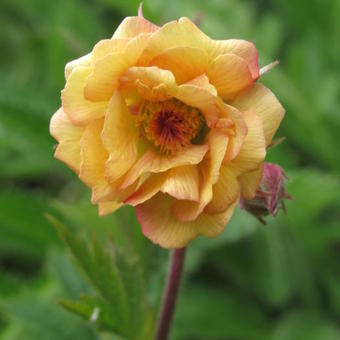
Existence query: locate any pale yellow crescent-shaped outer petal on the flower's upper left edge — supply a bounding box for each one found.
[61,67,107,125]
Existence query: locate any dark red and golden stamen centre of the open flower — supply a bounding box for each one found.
[137,99,205,154]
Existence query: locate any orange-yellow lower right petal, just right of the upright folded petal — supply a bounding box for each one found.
[204,165,240,214]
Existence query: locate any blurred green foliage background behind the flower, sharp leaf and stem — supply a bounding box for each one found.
[0,0,340,340]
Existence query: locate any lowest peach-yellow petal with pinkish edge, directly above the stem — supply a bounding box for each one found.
[135,193,237,248]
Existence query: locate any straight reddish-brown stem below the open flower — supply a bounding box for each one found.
[155,248,186,340]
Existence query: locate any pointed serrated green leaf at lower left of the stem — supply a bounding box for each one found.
[49,216,154,339]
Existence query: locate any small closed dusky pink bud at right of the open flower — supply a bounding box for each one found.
[240,163,293,224]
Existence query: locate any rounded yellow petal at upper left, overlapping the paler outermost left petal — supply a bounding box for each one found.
[84,34,149,101]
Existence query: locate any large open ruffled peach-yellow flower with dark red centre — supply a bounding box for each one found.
[50,17,284,248]
